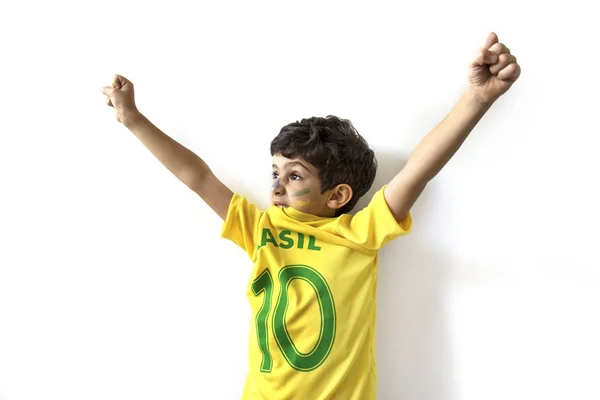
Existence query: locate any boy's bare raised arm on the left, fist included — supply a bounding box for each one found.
[102,75,233,220]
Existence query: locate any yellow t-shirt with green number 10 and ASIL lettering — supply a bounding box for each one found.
[221,188,412,400]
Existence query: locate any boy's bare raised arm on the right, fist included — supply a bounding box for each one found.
[384,33,521,222]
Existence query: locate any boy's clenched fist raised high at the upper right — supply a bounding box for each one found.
[468,32,521,104]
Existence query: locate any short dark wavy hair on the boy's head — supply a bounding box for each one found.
[271,115,377,216]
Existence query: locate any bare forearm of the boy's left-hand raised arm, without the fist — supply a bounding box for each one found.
[123,112,210,188]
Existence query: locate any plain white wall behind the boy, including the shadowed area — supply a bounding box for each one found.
[0,0,600,400]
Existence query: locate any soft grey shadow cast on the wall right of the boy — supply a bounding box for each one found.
[354,152,457,400]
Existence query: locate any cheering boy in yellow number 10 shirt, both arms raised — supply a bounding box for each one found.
[102,33,520,400]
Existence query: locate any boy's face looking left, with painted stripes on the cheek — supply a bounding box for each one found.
[271,154,335,217]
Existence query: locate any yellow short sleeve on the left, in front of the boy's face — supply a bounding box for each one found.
[221,193,263,259]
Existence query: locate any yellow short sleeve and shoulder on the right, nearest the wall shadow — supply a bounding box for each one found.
[337,186,412,251]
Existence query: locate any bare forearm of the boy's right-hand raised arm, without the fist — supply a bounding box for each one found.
[405,90,493,186]
